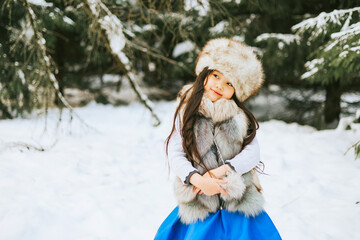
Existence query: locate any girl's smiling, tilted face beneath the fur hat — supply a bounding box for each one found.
[204,70,235,102]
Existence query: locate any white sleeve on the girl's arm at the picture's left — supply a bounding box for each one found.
[168,118,198,185]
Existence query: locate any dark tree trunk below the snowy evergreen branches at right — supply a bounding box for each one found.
[324,81,341,124]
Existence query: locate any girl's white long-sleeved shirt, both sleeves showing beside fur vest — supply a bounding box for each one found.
[168,117,260,184]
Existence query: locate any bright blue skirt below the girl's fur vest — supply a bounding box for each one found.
[155,207,281,240]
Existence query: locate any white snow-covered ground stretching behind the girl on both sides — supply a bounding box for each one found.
[0,102,360,240]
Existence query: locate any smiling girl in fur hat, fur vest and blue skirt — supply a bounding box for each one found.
[155,38,281,240]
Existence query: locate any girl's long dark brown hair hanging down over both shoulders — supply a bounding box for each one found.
[165,67,263,172]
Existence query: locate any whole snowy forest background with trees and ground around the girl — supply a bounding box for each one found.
[0,0,360,239]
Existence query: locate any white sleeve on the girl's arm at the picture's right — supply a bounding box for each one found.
[225,136,260,174]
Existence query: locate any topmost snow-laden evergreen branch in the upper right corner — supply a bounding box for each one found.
[291,7,360,39]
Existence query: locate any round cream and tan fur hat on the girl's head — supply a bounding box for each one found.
[195,38,264,102]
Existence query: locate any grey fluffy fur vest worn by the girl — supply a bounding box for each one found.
[174,93,264,224]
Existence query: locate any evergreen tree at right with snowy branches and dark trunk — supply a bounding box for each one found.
[292,7,360,123]
